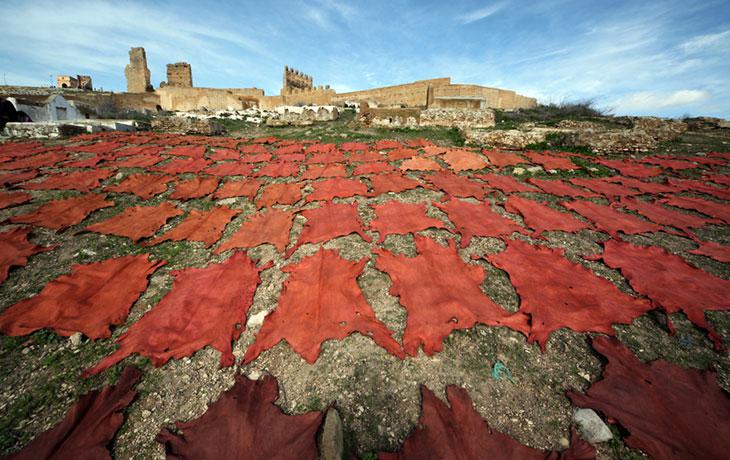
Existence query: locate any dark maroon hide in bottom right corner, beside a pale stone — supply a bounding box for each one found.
[568,337,730,459]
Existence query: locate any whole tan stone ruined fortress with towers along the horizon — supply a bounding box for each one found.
[0,48,537,112]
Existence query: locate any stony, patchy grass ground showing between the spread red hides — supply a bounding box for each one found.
[0,124,730,459]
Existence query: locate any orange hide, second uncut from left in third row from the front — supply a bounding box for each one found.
[86,201,183,241]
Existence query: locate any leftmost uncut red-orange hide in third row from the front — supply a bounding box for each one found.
[9,193,114,230]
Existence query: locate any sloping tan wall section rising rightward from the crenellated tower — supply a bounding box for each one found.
[332,77,451,107]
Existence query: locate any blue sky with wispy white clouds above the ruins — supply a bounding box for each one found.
[0,0,730,118]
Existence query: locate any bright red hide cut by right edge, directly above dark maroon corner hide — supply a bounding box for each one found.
[602,240,730,348]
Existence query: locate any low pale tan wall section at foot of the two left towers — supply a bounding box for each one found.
[155,86,264,111]
